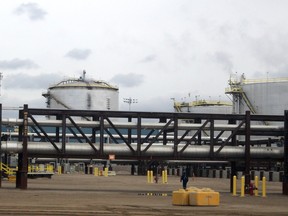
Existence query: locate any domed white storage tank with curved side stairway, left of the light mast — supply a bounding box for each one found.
[43,72,119,111]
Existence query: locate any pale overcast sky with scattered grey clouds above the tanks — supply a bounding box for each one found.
[0,0,288,116]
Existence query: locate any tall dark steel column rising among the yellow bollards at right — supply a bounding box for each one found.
[244,111,251,193]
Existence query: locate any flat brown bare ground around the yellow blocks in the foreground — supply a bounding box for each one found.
[0,173,288,216]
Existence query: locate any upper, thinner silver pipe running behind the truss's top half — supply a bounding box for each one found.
[2,119,284,132]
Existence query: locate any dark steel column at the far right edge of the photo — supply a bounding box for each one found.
[282,110,288,195]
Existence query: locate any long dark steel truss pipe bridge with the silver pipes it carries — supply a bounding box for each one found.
[0,105,288,195]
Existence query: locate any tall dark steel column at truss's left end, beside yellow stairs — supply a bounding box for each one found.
[16,104,28,189]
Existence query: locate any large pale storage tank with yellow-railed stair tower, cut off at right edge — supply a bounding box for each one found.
[226,75,288,118]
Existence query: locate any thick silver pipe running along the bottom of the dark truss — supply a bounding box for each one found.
[2,141,284,160]
